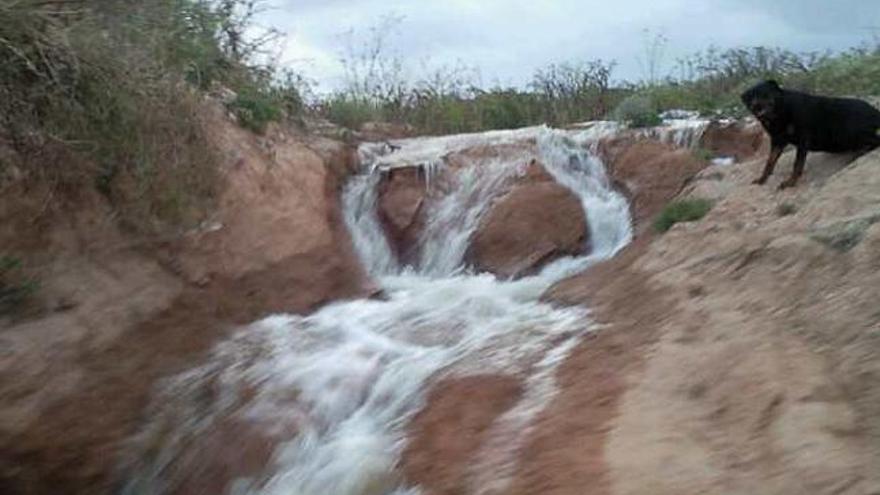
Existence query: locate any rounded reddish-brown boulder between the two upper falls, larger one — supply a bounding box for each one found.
[467,163,589,278]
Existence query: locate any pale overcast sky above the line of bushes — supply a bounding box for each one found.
[261,0,880,90]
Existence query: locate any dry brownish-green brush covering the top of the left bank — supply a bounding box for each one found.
[0,0,302,232]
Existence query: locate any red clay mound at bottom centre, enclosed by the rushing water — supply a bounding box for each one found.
[401,375,522,495]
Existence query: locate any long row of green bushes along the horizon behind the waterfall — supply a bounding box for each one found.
[314,18,880,134]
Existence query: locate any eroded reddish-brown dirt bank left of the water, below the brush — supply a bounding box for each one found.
[0,110,372,494]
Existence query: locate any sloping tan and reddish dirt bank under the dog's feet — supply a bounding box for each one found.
[404,141,880,494]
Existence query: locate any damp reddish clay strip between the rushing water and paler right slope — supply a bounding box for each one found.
[506,238,674,495]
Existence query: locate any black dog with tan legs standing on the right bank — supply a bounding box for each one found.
[742,81,880,189]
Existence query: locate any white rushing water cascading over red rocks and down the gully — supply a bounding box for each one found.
[125,118,708,495]
